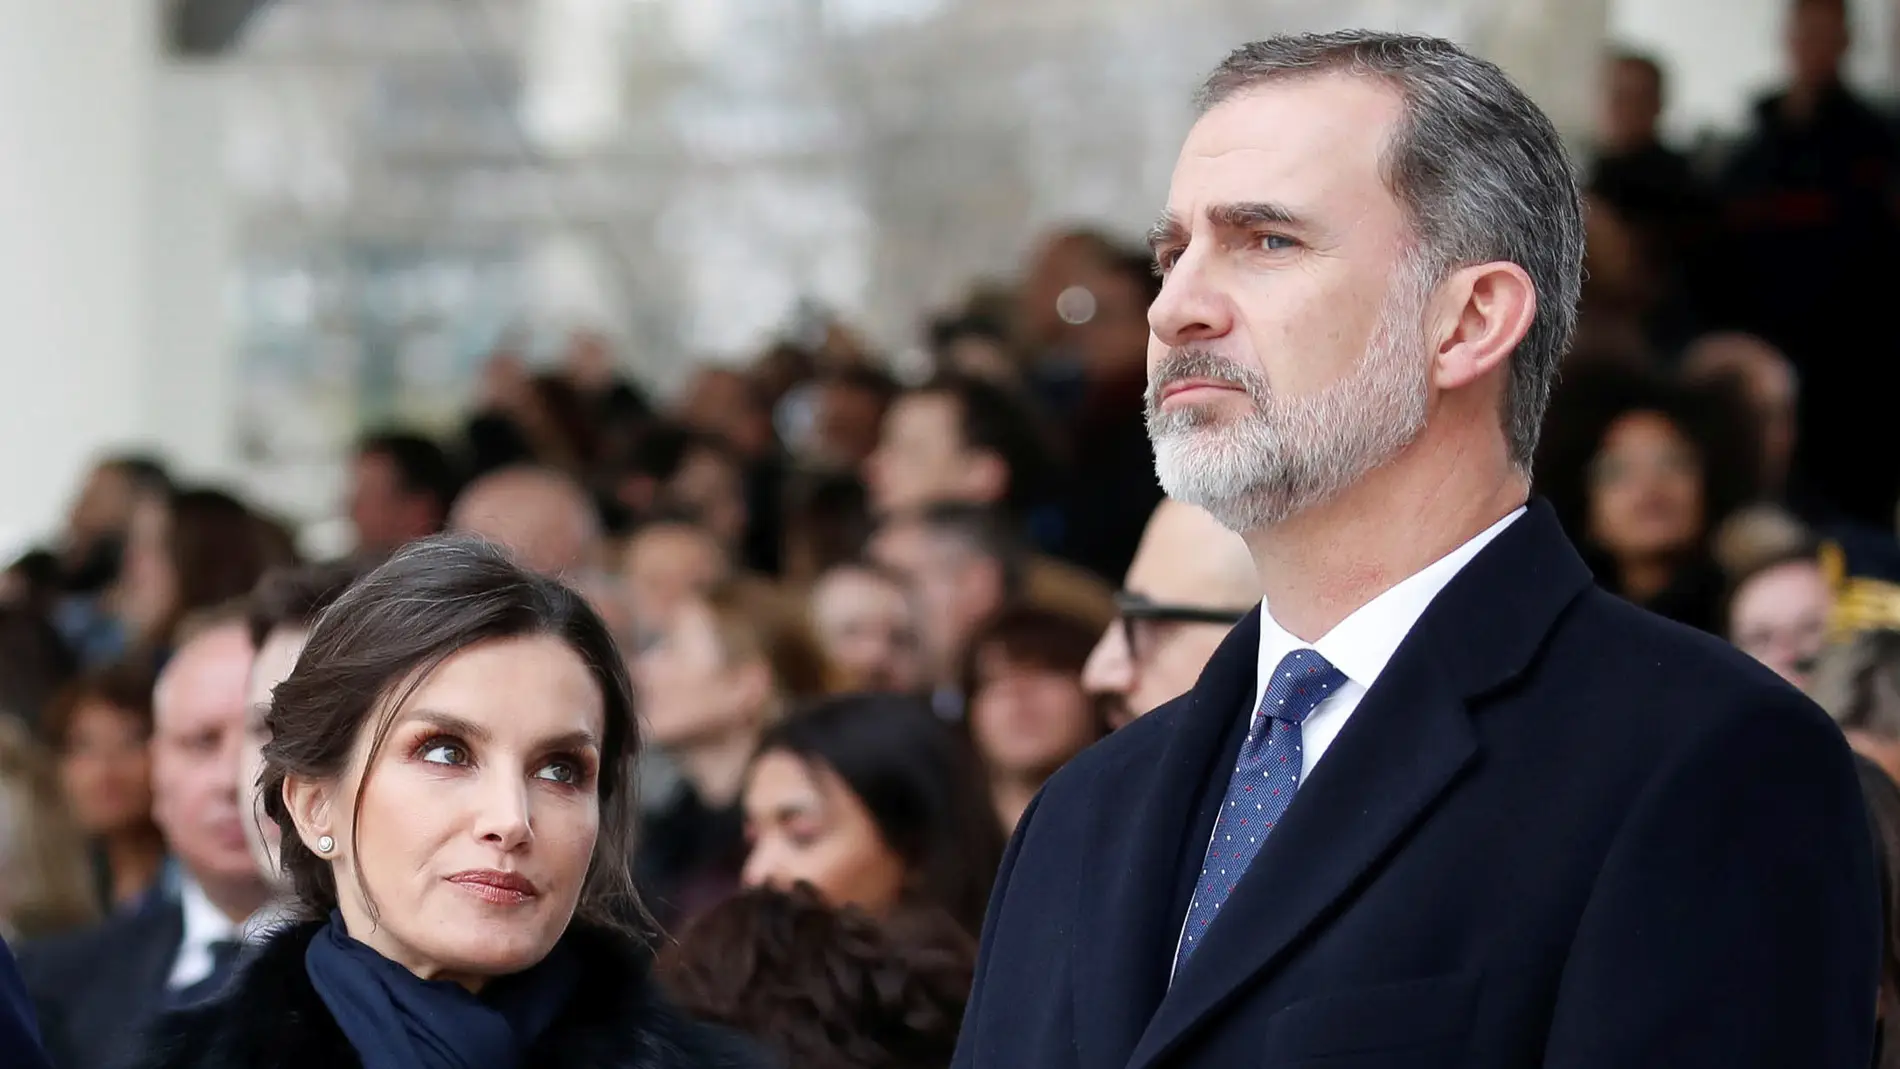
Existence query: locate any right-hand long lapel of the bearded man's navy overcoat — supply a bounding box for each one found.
[1117,503,1590,1069]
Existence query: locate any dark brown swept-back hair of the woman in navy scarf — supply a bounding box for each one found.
[262,535,650,930]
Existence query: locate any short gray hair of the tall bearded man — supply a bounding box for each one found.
[1195,30,1583,473]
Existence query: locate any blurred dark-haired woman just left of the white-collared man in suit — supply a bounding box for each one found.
[40,661,165,911]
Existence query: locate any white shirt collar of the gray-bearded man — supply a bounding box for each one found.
[1256,505,1526,689]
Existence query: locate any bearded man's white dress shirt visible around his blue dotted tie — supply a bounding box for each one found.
[1170,507,1524,982]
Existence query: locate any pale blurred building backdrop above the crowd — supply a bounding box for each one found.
[0,0,1894,547]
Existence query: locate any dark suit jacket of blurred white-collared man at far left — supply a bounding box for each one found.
[19,894,184,1069]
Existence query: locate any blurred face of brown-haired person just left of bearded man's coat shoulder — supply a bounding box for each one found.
[969,646,1098,782]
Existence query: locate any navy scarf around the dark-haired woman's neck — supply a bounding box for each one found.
[304,913,578,1069]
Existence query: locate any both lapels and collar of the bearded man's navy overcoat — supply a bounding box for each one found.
[1075,501,1590,1069]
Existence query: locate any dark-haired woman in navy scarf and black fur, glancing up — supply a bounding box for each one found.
[133,537,749,1069]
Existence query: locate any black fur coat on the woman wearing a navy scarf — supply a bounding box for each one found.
[141,925,770,1069]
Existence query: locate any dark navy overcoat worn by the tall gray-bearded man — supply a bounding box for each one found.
[956,503,1881,1069]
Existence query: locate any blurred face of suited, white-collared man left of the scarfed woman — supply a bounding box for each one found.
[152,625,260,900]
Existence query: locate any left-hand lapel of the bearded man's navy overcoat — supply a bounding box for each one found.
[1074,608,1260,1069]
